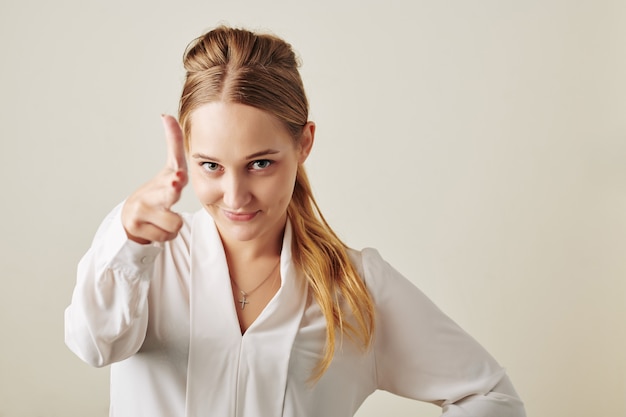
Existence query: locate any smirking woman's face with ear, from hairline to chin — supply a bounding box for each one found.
[189,102,314,244]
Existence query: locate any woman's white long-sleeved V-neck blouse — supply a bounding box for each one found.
[65,206,525,417]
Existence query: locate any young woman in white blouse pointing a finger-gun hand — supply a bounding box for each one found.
[65,27,524,417]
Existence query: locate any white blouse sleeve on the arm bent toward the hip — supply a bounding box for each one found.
[363,249,526,417]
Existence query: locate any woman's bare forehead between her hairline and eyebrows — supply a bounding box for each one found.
[189,102,294,156]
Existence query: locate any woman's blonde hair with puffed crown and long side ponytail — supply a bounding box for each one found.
[179,26,374,380]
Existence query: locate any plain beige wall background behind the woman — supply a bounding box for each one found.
[0,0,626,417]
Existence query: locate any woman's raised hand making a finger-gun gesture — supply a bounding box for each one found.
[122,115,188,244]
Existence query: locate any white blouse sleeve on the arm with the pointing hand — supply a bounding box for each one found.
[65,205,162,367]
